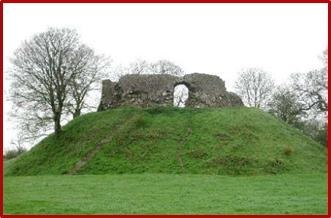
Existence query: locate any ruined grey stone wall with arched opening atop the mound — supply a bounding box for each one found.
[98,73,243,111]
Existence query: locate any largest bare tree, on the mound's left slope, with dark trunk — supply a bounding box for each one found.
[11,28,104,135]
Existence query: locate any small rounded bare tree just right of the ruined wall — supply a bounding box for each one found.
[235,68,274,108]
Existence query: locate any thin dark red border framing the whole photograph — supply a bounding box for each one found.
[0,0,331,218]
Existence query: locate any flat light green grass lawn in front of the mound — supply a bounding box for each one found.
[4,173,327,214]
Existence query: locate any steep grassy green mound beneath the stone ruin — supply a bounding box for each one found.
[5,108,326,175]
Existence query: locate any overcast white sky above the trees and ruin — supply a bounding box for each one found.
[4,4,328,150]
